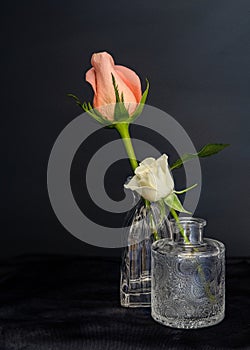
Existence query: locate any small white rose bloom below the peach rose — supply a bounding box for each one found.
[124,154,174,202]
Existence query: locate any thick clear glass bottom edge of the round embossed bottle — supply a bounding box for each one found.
[151,311,225,329]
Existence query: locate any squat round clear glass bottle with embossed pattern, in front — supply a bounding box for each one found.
[151,217,225,328]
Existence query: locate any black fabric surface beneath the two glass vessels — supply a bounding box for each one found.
[0,256,250,350]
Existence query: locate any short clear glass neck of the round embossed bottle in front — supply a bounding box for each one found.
[171,217,206,245]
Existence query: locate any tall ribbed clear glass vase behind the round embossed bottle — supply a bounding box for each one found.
[120,193,169,307]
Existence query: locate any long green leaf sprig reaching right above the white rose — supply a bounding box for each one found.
[170,143,229,170]
